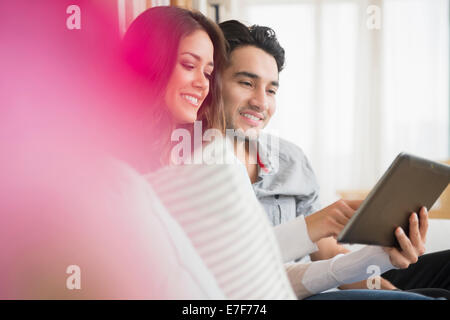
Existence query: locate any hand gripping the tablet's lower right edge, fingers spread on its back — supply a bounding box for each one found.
[384,207,428,269]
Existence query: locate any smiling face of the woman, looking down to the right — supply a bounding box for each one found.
[164,30,214,124]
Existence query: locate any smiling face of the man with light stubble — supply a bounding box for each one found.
[223,46,278,137]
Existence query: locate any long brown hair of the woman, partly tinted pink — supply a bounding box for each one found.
[123,6,227,169]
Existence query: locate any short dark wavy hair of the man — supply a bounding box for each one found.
[219,20,284,72]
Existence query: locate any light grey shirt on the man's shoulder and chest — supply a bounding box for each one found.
[252,133,321,226]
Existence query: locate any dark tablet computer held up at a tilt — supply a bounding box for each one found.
[337,153,450,247]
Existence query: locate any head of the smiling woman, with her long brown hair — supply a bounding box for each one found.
[124,6,226,171]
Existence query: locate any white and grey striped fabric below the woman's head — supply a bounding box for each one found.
[147,141,295,299]
